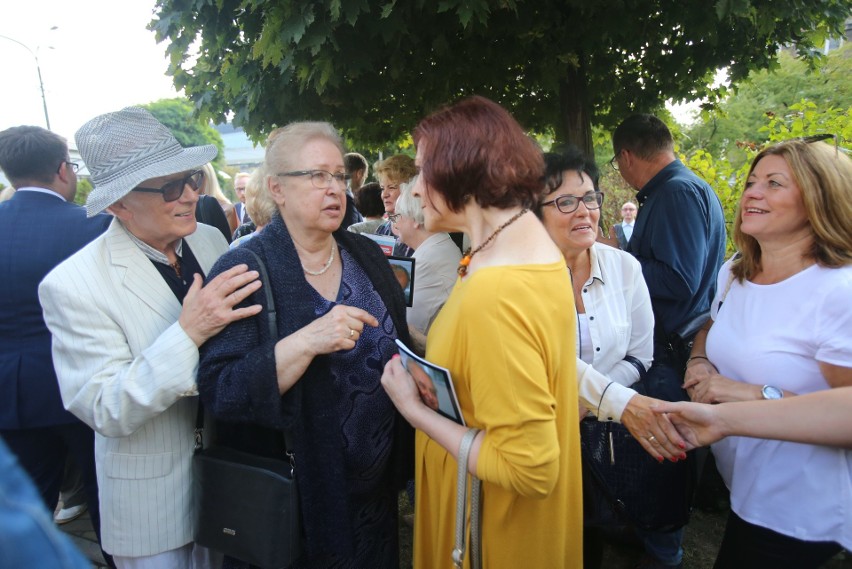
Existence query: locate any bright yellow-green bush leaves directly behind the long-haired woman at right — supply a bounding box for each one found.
[680,100,852,253]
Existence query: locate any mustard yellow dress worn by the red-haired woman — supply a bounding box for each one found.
[414,262,583,569]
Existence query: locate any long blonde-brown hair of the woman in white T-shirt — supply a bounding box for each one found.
[732,139,852,282]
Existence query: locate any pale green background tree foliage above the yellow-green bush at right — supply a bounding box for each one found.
[684,44,852,164]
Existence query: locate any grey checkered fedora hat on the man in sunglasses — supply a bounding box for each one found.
[74,107,218,217]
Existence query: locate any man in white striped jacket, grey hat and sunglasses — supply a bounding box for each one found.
[39,107,260,569]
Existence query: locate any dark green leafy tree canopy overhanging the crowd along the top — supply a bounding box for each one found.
[150,0,850,152]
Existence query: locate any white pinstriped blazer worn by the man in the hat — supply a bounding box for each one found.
[39,221,227,557]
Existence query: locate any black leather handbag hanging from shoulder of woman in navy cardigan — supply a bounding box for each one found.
[192,249,302,569]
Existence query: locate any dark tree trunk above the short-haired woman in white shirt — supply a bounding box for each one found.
[556,61,595,158]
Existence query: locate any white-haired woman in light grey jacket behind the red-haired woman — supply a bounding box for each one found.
[389,176,461,334]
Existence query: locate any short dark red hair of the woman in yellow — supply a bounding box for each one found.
[414,96,544,211]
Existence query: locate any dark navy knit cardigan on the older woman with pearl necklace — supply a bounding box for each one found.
[198,216,414,556]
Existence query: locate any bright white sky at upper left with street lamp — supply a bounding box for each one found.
[0,0,178,144]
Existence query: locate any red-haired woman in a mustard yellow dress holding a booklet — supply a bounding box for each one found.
[382,97,583,569]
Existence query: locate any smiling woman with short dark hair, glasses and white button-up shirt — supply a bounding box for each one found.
[536,147,686,567]
